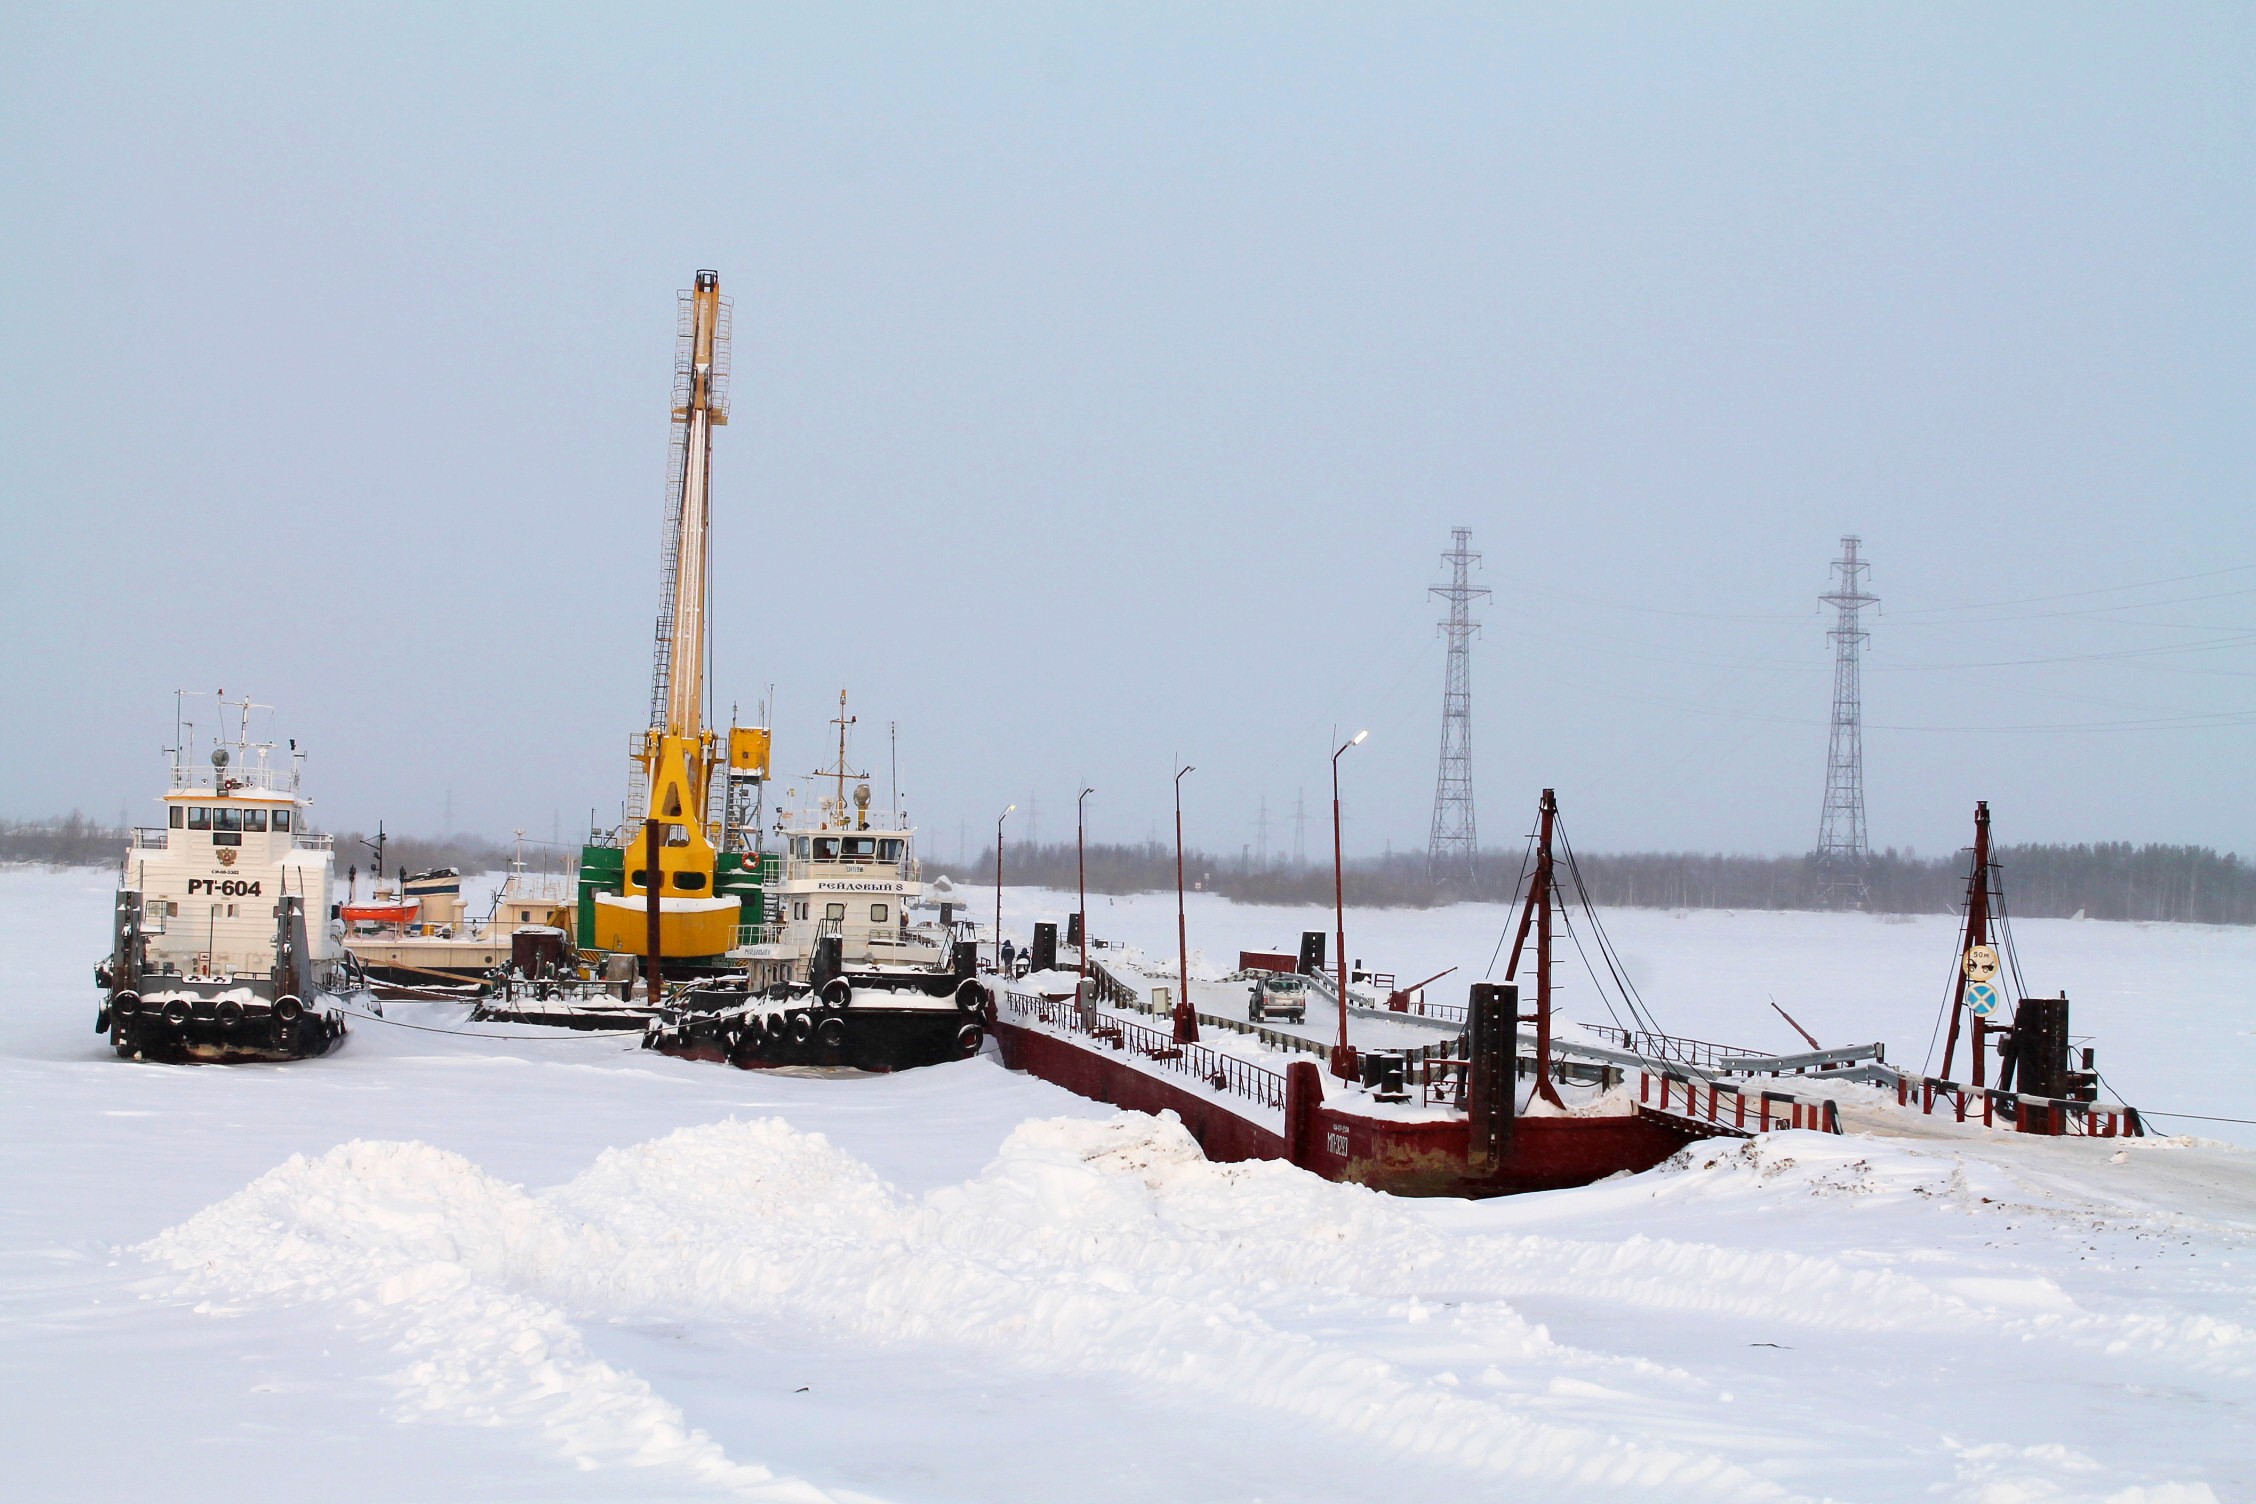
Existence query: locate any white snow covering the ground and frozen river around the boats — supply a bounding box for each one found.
[0,870,2256,1504]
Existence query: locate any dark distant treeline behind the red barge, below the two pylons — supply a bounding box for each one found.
[961,841,2256,924]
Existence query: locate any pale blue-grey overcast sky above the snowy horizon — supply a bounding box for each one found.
[0,5,2256,857]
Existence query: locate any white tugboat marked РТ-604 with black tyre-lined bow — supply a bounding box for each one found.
[95,699,347,1060]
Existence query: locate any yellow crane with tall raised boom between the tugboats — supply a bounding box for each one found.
[589,271,769,958]
